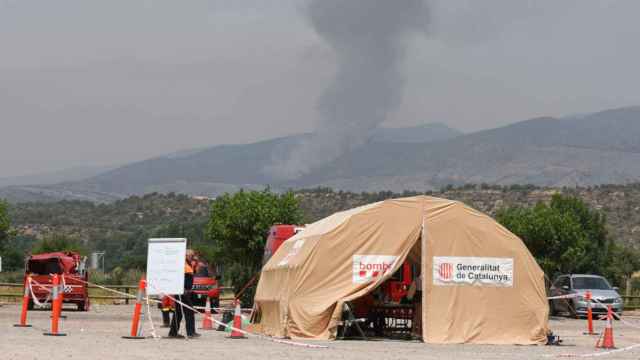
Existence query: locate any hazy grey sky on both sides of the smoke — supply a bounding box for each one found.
[0,0,640,178]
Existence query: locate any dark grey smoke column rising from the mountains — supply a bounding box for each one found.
[267,0,427,179]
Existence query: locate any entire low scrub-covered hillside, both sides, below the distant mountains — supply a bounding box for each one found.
[9,184,640,268]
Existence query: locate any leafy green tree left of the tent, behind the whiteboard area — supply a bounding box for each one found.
[205,189,302,304]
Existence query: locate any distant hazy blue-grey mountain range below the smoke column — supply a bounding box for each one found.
[0,107,640,202]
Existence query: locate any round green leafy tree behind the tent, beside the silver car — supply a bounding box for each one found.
[496,194,613,277]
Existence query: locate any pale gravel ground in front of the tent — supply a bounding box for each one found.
[0,304,640,360]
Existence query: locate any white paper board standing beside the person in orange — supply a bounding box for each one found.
[147,238,187,295]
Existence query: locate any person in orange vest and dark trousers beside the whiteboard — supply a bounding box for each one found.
[169,250,200,338]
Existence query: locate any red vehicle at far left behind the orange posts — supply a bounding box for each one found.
[24,251,91,311]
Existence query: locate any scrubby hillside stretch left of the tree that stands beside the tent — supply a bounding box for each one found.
[10,194,209,269]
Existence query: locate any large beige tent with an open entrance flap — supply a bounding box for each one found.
[255,196,548,344]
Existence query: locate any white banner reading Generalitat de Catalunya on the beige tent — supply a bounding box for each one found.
[433,256,513,287]
